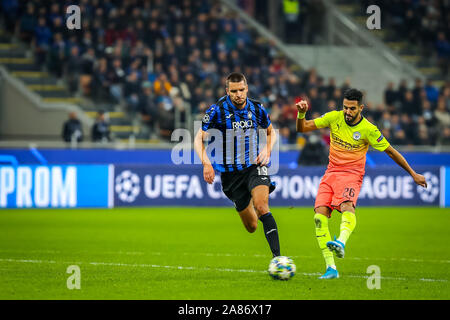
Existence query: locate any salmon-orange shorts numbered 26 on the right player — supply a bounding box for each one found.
[331,173,363,212]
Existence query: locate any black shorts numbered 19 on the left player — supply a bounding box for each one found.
[221,165,270,212]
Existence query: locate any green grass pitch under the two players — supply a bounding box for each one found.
[0,207,450,300]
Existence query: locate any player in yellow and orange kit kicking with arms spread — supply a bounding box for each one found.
[296,89,427,279]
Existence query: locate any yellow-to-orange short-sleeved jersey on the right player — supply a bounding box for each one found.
[314,110,390,174]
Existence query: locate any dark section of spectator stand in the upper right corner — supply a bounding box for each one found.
[338,0,450,85]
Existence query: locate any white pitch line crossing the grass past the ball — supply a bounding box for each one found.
[0,259,448,282]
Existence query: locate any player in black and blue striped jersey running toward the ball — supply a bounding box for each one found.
[194,72,280,257]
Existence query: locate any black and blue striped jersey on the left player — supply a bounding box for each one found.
[202,95,271,172]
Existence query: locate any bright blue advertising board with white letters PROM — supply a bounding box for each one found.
[0,165,109,208]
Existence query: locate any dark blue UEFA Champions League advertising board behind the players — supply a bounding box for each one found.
[112,165,441,207]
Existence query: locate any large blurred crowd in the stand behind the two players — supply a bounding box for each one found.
[0,0,450,145]
